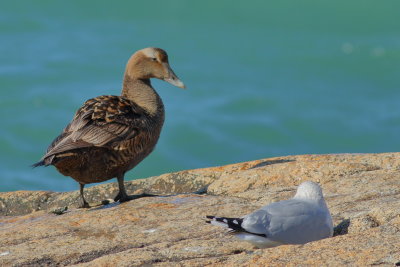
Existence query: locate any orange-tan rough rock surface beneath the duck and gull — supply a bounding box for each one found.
[0,153,400,266]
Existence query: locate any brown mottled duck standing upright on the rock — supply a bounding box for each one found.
[33,47,185,207]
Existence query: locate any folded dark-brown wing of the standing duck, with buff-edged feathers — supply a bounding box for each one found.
[43,95,146,159]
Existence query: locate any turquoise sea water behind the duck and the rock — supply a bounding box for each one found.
[0,0,400,191]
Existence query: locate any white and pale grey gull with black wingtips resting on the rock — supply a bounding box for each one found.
[207,181,333,248]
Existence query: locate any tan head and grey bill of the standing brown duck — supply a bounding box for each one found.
[125,47,185,88]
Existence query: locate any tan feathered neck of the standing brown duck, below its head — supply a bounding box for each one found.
[121,74,163,115]
